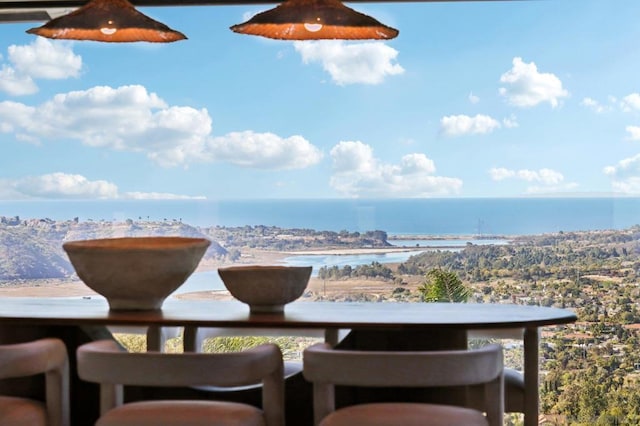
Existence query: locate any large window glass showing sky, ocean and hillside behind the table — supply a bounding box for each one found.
[0,0,640,424]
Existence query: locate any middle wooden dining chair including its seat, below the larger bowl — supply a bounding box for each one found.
[77,340,284,426]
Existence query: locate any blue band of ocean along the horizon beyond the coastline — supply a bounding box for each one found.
[0,197,640,236]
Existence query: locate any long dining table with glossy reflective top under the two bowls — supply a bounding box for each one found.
[0,296,577,426]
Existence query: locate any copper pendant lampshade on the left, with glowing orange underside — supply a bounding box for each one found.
[27,0,187,43]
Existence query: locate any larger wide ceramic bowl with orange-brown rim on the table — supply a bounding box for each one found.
[62,237,211,310]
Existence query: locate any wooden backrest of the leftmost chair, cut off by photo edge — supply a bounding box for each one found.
[0,338,70,426]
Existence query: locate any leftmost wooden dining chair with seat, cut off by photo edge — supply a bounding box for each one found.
[0,338,70,426]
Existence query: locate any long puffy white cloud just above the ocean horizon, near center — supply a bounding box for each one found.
[330,141,462,198]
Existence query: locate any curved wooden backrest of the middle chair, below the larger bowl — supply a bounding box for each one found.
[77,340,284,425]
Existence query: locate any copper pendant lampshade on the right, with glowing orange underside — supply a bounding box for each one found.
[231,0,398,40]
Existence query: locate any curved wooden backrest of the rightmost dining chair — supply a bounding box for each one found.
[303,343,504,425]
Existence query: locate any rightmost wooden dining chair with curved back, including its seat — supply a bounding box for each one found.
[303,343,504,426]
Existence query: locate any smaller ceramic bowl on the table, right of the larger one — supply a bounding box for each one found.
[218,265,312,313]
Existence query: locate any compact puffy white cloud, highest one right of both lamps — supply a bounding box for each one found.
[500,57,569,108]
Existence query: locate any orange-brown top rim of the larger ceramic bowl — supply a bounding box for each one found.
[62,236,211,251]
